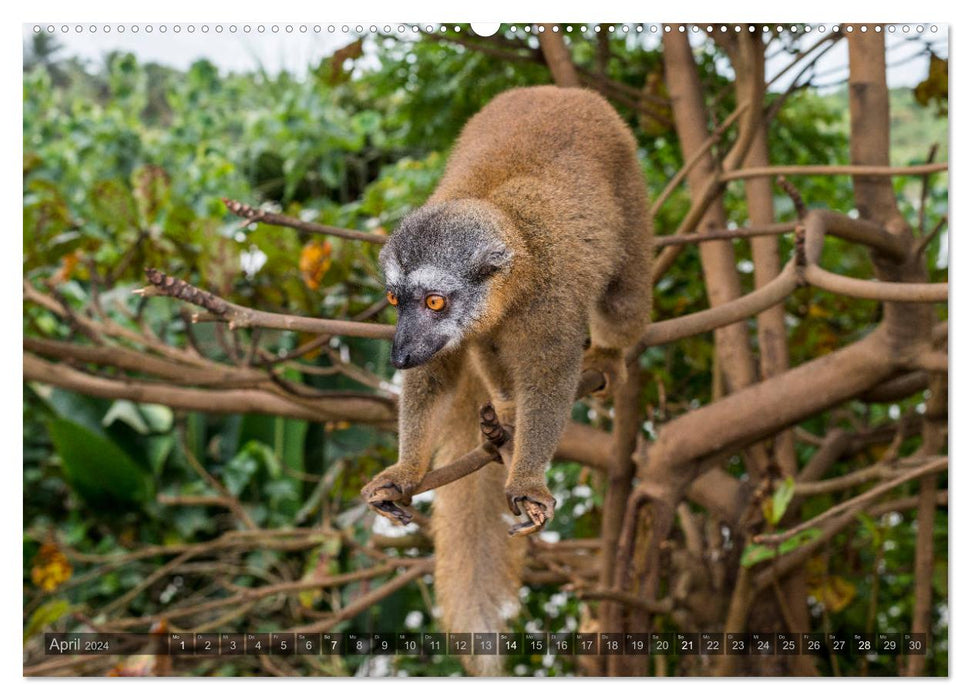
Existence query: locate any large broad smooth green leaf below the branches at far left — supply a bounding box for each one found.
[48,418,154,507]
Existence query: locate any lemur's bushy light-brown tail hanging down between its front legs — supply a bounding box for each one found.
[432,370,525,675]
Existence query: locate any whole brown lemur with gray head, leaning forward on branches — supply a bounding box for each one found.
[362,86,652,673]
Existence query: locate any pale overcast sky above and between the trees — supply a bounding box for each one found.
[23,22,948,89]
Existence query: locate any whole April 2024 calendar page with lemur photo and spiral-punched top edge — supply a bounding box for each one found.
[21,20,950,690]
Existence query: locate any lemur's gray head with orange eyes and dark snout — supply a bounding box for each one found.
[380,203,512,369]
